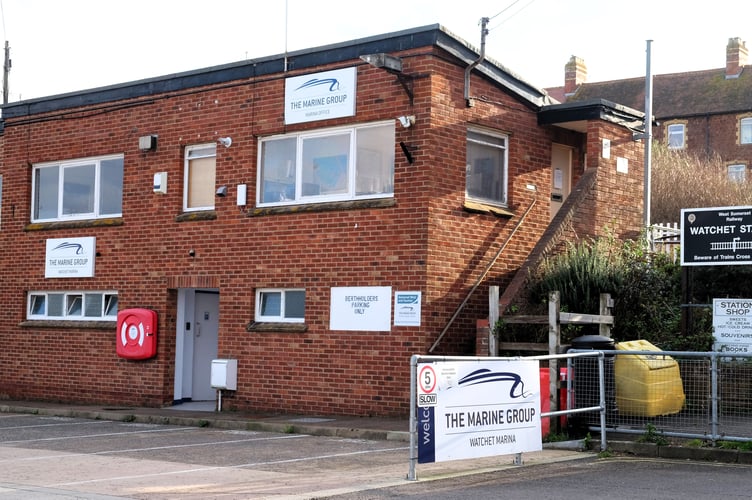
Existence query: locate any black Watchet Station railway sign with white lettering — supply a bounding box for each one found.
[681,207,752,266]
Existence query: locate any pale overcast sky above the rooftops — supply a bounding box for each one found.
[0,0,752,102]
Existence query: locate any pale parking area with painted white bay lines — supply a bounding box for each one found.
[0,413,591,500]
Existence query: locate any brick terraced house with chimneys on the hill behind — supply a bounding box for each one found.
[547,38,752,181]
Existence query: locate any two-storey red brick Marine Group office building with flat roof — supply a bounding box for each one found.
[0,25,642,415]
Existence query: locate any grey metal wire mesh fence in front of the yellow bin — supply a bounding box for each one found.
[561,350,752,441]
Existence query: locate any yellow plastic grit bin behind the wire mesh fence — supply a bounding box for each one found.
[614,340,684,417]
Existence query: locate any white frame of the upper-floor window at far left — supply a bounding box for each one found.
[31,154,125,222]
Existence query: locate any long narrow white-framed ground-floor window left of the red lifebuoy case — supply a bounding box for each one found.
[26,291,118,321]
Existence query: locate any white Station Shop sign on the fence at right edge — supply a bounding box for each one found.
[713,299,752,354]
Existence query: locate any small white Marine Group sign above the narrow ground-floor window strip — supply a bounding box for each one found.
[44,236,96,278]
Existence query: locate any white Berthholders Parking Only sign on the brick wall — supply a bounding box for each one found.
[329,286,392,332]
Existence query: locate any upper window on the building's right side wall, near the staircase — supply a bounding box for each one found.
[465,130,508,206]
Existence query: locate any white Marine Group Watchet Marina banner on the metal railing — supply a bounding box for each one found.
[415,359,543,463]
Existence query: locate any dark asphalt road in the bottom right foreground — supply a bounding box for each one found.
[321,457,752,500]
